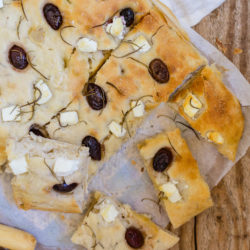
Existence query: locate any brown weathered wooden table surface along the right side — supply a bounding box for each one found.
[172,0,250,250]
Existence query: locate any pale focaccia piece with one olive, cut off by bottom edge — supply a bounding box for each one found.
[71,193,178,250]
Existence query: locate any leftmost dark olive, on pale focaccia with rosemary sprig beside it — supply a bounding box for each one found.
[9,45,29,69]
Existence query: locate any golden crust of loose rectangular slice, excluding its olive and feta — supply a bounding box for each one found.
[138,129,213,228]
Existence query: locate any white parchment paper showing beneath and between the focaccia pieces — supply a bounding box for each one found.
[0,9,250,250]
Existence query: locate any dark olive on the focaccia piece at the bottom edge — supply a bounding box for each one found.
[125,227,144,249]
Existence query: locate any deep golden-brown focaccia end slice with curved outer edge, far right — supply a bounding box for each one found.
[172,66,244,161]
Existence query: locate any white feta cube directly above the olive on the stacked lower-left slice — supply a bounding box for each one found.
[53,157,80,176]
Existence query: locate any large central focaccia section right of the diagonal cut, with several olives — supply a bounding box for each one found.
[45,8,206,176]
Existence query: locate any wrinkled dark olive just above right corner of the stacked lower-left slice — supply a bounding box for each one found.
[82,136,102,161]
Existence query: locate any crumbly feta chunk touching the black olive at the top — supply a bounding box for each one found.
[106,17,126,40]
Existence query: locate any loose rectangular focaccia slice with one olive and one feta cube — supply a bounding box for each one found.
[138,129,213,228]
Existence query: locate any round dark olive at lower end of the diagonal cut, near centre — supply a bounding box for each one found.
[86,83,107,110]
